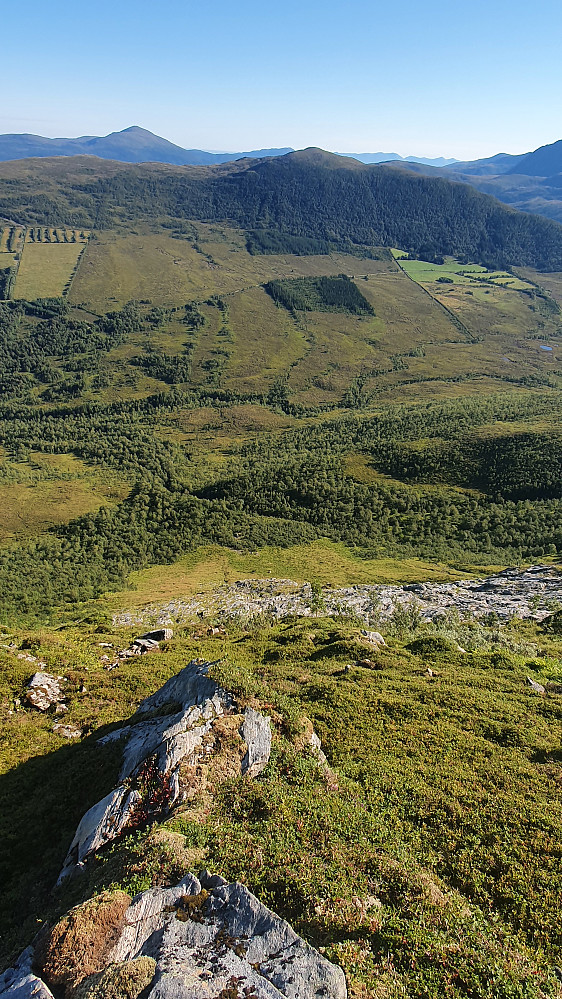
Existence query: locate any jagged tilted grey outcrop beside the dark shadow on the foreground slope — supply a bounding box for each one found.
[59,660,271,882]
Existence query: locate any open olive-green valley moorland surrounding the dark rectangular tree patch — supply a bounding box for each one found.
[63,223,560,405]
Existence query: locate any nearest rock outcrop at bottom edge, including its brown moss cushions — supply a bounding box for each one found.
[4,872,347,999]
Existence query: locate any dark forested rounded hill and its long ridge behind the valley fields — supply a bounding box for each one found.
[0,149,562,270]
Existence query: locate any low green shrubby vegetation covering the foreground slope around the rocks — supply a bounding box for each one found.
[0,615,562,999]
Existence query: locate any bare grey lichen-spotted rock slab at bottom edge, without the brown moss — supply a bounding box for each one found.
[108,875,347,999]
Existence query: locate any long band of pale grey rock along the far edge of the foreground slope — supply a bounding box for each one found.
[110,565,562,624]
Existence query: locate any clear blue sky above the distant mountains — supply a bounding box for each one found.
[4,0,562,159]
